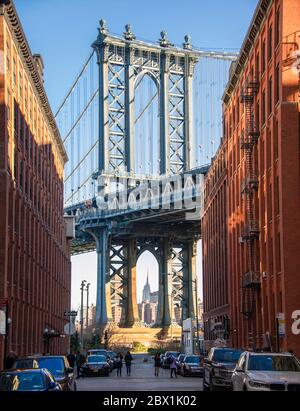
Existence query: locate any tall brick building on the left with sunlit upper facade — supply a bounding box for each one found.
[0,0,71,365]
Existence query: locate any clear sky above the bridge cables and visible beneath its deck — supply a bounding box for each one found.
[15,0,258,308]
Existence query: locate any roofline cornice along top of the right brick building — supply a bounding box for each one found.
[223,0,273,104]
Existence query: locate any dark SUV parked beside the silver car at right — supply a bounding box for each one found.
[203,347,243,391]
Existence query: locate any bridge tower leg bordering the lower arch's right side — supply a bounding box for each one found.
[157,239,173,327]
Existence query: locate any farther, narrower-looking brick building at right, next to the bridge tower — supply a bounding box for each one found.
[202,142,229,341]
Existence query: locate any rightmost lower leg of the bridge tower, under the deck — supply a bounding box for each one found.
[182,240,198,320]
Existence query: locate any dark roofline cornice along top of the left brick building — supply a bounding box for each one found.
[0,0,68,163]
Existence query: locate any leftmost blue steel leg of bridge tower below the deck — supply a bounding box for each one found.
[91,227,112,327]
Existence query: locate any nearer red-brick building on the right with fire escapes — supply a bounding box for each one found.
[203,0,300,356]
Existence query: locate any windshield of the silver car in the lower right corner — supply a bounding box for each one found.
[248,355,300,372]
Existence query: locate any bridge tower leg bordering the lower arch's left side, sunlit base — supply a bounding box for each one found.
[124,240,139,327]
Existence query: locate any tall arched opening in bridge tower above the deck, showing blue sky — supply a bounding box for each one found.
[134,72,160,175]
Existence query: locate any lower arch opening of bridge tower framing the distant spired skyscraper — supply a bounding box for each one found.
[136,250,159,325]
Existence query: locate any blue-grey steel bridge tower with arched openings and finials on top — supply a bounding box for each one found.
[73,20,200,334]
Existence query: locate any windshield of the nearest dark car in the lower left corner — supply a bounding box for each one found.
[0,372,45,391]
